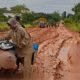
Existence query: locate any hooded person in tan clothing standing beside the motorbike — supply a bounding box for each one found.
[1,18,34,80]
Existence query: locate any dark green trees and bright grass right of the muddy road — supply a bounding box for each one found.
[64,3,80,32]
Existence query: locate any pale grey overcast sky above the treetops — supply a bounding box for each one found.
[0,0,80,13]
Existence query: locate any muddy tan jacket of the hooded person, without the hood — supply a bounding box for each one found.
[5,25,34,57]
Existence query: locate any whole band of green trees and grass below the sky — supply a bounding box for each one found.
[0,3,80,32]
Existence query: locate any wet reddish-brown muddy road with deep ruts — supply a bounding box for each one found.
[0,27,80,80]
